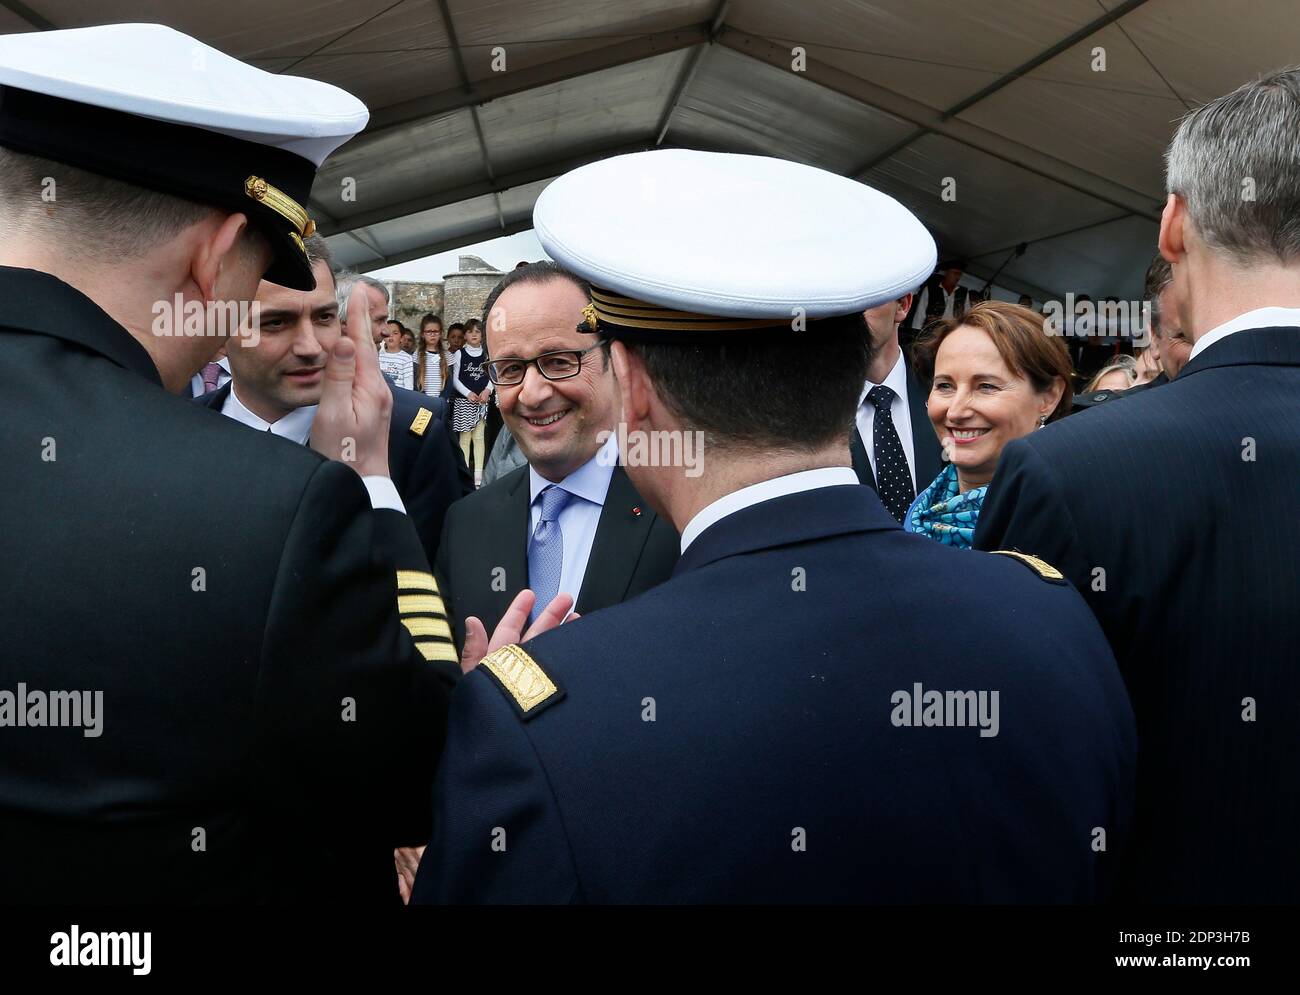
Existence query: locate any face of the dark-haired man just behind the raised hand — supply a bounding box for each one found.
[229,261,341,421]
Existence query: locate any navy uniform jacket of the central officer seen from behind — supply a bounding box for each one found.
[416,485,1135,903]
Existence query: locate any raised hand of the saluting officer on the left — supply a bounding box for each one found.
[312,282,393,477]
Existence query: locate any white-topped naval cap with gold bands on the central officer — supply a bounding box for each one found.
[533,150,937,341]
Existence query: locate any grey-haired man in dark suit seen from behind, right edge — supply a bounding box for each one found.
[975,70,1300,904]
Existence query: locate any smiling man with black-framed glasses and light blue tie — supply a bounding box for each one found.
[437,261,677,645]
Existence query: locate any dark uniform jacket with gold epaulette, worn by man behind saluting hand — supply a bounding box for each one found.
[195,384,475,563]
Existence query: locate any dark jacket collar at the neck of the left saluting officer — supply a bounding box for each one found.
[0,267,163,386]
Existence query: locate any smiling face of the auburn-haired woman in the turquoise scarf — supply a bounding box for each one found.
[926,325,1065,490]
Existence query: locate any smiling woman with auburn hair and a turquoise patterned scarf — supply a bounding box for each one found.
[904,300,1074,549]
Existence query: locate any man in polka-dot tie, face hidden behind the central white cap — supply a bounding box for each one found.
[849,294,944,522]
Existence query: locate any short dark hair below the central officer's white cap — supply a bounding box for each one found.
[624,312,872,457]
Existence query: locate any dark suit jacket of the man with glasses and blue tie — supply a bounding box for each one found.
[436,464,679,645]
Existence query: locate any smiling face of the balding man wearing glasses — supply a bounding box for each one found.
[488,278,618,481]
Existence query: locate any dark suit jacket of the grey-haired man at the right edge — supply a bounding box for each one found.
[975,328,1300,904]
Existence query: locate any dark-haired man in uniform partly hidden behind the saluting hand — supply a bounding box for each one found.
[198,235,473,563]
